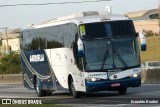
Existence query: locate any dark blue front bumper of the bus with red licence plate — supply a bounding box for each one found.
[85,77,141,92]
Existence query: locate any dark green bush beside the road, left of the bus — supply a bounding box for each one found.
[0,52,21,74]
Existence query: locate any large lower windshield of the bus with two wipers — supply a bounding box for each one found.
[84,38,140,71]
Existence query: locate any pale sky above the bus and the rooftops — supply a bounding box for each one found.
[0,0,160,29]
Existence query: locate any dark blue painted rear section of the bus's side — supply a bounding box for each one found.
[21,50,66,90]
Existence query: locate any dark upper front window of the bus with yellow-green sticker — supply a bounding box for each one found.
[79,20,135,40]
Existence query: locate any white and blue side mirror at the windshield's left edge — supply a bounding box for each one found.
[77,38,84,57]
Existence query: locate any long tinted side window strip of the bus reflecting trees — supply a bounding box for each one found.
[21,23,77,51]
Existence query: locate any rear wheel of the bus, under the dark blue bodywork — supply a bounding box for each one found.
[35,78,45,97]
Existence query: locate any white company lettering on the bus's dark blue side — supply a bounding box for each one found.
[30,54,44,62]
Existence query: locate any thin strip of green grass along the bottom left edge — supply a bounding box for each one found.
[0,104,72,107]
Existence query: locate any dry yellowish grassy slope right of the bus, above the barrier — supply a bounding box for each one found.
[141,36,160,63]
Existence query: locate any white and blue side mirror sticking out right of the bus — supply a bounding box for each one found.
[139,30,147,51]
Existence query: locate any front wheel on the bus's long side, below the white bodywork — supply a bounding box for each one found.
[69,80,81,98]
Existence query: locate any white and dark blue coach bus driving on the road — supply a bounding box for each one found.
[21,11,146,98]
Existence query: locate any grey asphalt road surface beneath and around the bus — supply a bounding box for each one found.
[0,84,160,107]
